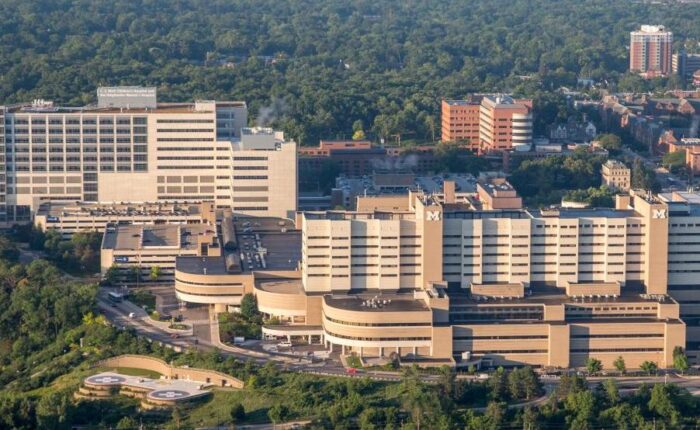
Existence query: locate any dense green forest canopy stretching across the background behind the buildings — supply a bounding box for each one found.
[0,0,700,144]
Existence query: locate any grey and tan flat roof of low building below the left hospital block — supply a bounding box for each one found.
[102,224,213,250]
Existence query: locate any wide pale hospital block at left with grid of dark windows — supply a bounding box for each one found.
[0,87,296,225]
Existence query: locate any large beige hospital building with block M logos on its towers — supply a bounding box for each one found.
[168,188,700,368]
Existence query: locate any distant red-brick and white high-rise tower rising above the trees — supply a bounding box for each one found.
[630,25,673,78]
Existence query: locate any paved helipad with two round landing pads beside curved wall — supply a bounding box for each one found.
[84,372,210,403]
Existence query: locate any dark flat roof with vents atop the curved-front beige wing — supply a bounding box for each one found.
[323,292,430,312]
